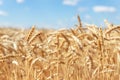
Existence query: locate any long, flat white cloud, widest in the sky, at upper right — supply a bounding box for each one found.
[93,6,116,12]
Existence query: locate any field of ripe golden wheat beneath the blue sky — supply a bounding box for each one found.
[0,16,120,80]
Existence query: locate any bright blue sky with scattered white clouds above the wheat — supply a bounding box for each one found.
[0,0,120,29]
